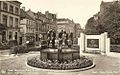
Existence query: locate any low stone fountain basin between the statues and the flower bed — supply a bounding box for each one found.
[40,48,80,61]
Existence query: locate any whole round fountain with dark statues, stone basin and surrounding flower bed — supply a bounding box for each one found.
[27,30,93,70]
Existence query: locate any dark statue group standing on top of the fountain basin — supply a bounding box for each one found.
[47,30,73,48]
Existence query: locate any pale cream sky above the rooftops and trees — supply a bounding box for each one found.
[18,0,113,27]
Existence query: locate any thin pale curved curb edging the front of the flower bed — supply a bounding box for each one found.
[25,62,96,73]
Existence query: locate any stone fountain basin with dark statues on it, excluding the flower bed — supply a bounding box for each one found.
[40,30,80,62]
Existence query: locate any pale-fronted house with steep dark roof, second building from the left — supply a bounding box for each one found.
[20,9,36,44]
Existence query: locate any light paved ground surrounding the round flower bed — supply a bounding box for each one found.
[0,52,120,75]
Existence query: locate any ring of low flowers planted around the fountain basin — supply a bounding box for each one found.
[27,56,93,70]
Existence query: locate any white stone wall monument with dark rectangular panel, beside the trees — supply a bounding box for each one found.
[78,32,110,54]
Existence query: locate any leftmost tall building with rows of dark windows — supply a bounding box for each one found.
[0,1,21,42]
